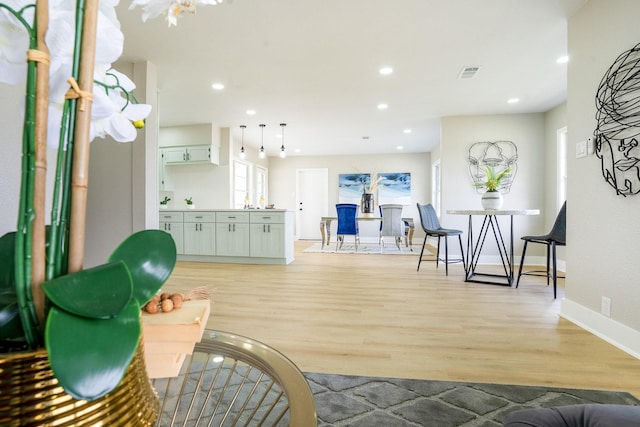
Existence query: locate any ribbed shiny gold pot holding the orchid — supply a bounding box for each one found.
[0,343,159,427]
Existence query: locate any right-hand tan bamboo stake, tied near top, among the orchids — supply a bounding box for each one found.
[69,0,98,273]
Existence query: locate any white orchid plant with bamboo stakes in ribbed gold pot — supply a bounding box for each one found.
[0,0,220,426]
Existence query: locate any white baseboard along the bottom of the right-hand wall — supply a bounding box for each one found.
[560,299,640,359]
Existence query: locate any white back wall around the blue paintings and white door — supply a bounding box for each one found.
[269,153,431,243]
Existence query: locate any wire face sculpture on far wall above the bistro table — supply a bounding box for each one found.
[469,141,518,194]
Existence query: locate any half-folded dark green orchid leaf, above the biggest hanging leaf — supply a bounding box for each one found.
[42,261,133,319]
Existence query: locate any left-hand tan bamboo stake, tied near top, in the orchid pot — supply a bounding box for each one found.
[31,0,49,325]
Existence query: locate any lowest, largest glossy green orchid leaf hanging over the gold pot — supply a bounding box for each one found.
[45,300,141,400]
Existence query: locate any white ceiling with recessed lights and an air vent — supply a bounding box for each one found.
[118,0,586,155]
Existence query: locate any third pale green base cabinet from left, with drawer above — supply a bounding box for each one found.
[216,211,250,257]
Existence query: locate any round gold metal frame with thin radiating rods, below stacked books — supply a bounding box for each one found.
[153,330,317,427]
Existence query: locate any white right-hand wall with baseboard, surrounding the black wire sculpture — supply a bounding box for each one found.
[562,0,640,357]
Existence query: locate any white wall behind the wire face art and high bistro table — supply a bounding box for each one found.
[440,114,546,263]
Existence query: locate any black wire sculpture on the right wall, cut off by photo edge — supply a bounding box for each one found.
[593,44,640,197]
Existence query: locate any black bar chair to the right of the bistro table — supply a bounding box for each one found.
[516,201,567,299]
